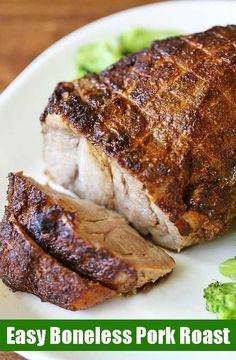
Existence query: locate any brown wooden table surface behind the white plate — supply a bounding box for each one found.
[0,0,164,360]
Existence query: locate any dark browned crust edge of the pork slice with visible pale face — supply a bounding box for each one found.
[8,173,137,292]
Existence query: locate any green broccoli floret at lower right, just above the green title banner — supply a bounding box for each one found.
[204,281,236,320]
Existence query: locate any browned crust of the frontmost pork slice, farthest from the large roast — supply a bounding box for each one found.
[0,209,117,311]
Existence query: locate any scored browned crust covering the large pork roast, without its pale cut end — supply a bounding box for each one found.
[41,25,236,245]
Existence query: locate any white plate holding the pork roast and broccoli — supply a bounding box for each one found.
[0,1,236,359]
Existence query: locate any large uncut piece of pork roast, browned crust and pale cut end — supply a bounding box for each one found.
[41,25,236,250]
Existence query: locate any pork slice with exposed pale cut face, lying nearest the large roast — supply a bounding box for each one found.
[8,173,174,292]
